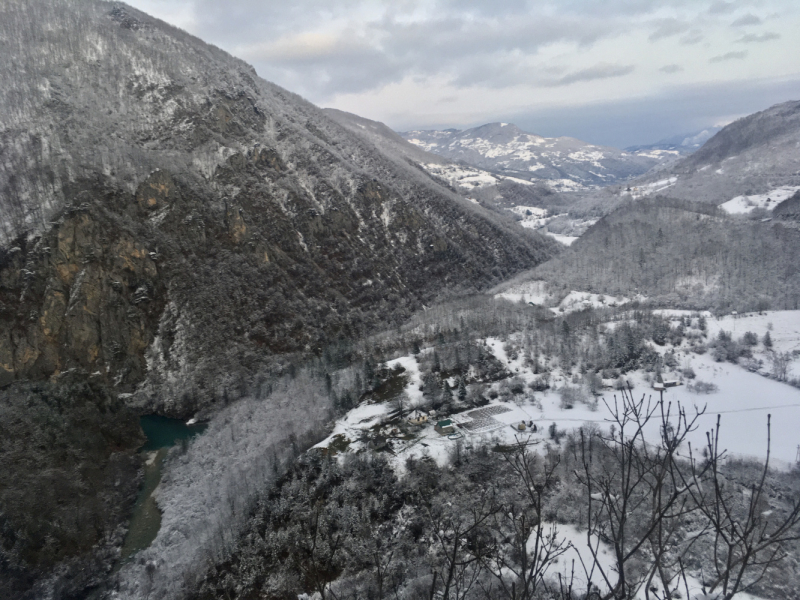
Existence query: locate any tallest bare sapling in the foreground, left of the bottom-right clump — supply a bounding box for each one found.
[573,389,704,600]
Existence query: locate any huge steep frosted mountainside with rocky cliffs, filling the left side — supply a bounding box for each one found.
[0,0,555,597]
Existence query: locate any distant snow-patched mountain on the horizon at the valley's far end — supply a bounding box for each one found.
[400,123,679,189]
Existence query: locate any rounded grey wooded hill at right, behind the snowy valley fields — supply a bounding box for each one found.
[533,198,800,310]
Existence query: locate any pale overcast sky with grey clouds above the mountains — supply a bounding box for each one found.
[128,0,800,147]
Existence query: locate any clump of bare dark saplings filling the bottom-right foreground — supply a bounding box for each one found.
[573,389,800,600]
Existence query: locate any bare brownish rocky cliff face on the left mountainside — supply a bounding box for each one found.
[0,192,164,391]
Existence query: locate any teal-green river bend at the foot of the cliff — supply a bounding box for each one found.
[120,415,206,562]
